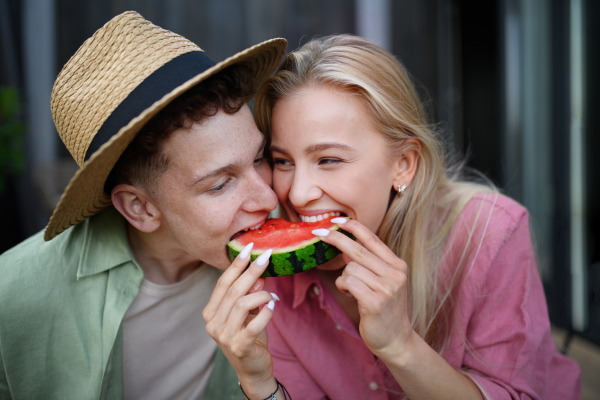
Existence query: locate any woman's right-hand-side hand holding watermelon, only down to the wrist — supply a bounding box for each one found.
[313,218,413,360]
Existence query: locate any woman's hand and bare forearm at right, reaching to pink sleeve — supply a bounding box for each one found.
[313,218,482,399]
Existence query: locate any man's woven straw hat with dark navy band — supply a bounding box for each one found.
[44,11,287,240]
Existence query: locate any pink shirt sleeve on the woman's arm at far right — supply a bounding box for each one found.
[463,213,577,399]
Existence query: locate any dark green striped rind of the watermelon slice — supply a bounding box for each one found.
[227,225,356,278]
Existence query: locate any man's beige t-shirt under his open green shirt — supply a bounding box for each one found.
[123,264,221,400]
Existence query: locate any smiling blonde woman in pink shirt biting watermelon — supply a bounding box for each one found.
[203,35,580,400]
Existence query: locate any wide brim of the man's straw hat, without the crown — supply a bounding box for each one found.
[44,38,287,241]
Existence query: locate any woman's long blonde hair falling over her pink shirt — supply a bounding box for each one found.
[254,35,494,351]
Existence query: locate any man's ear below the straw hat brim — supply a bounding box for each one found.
[110,184,161,233]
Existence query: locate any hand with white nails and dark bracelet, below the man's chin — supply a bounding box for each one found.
[202,245,279,399]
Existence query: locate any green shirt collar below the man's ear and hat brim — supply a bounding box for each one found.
[77,207,139,279]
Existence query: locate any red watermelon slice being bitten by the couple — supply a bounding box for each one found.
[227,216,355,277]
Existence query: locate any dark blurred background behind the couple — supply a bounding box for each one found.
[0,0,600,394]
